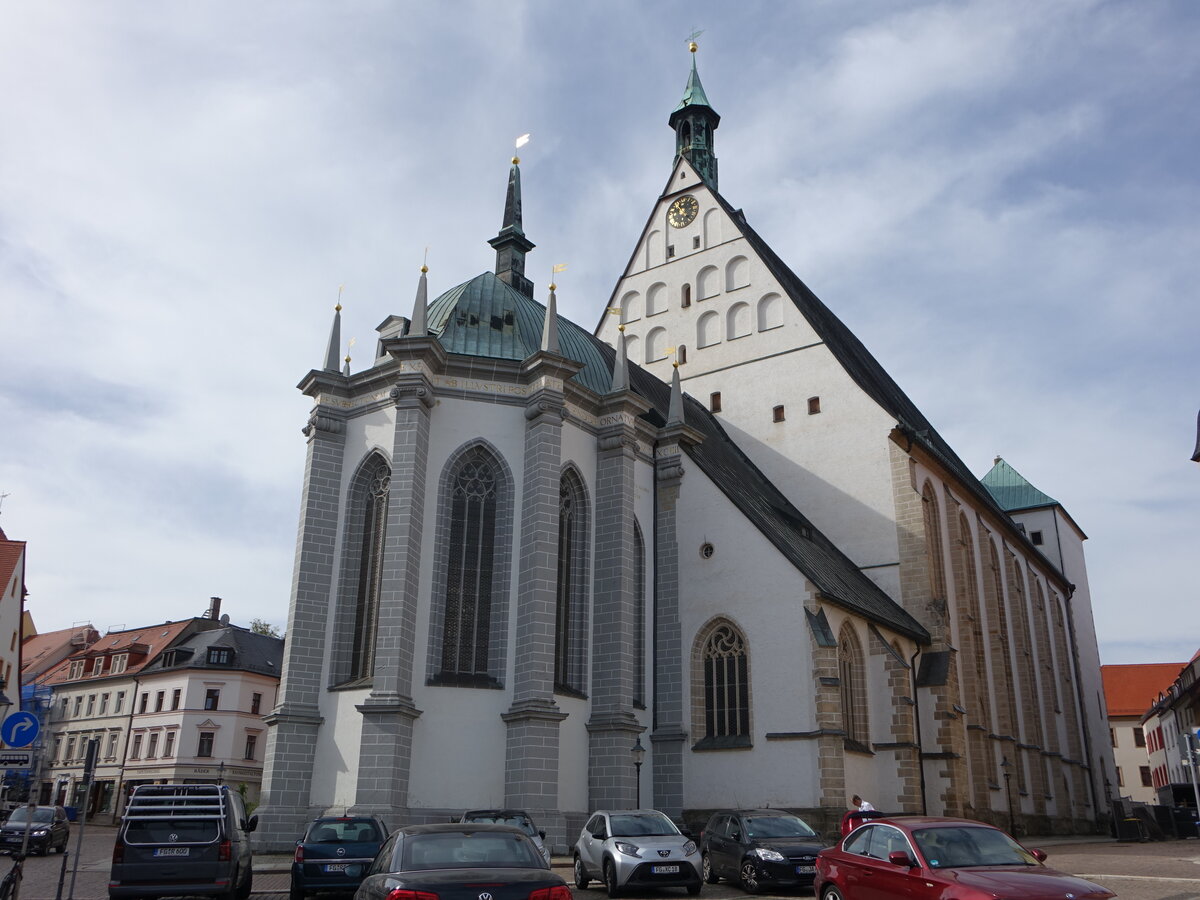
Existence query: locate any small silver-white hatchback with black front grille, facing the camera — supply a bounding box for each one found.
[572,809,703,896]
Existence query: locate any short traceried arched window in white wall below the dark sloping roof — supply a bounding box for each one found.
[692,619,750,746]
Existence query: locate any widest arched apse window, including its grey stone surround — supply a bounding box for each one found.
[428,444,512,688]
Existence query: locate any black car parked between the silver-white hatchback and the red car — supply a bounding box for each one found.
[700,809,826,894]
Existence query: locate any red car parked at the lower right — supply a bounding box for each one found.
[812,816,1116,900]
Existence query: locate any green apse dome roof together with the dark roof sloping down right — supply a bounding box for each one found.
[428,264,929,643]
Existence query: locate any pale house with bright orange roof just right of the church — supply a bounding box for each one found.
[1100,662,1187,803]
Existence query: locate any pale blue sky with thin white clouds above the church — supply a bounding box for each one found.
[0,0,1200,664]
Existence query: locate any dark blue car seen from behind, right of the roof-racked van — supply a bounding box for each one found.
[290,816,388,900]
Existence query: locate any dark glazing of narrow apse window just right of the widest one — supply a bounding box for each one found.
[554,469,588,694]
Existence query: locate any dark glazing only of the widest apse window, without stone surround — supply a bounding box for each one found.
[442,455,498,679]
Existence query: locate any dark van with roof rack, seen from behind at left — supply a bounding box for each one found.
[108,785,258,900]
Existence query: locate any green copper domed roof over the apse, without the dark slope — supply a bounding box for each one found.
[428,272,612,394]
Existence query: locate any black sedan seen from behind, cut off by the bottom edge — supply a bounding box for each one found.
[354,823,571,900]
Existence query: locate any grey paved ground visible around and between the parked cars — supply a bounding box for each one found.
[14,826,1200,900]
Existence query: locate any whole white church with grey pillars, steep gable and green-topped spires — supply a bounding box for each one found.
[256,46,1115,852]
